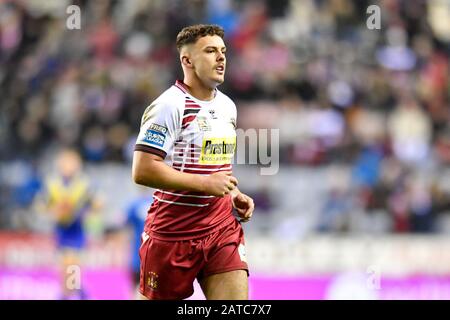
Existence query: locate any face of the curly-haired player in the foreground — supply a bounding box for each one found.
[192,35,227,87]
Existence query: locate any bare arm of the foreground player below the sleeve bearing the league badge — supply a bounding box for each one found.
[133,151,238,197]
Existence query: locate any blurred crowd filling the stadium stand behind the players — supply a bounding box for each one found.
[0,0,450,233]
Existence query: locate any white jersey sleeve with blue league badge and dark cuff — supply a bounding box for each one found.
[135,100,180,159]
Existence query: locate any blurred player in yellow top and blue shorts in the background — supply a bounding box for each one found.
[37,149,101,299]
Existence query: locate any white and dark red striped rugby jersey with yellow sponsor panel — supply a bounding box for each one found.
[135,80,236,241]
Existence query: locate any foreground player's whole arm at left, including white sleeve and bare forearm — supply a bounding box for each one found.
[132,98,238,197]
